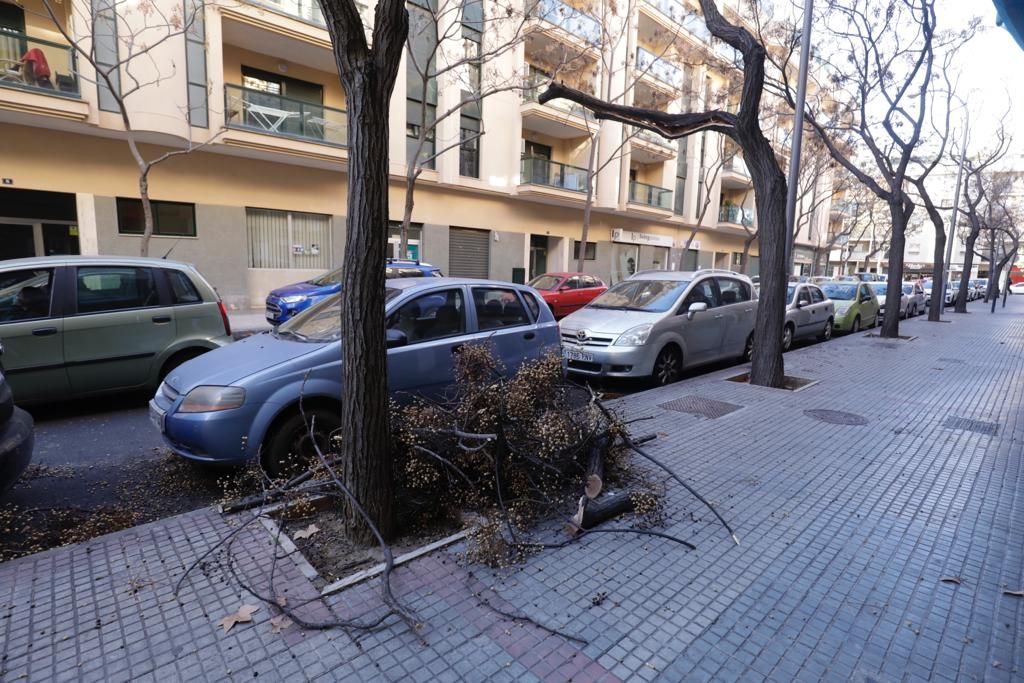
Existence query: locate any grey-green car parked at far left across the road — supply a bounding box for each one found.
[0,256,231,402]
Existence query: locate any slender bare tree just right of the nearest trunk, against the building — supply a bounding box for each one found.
[398,0,529,258]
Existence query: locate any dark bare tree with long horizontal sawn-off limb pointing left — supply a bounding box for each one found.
[541,0,786,387]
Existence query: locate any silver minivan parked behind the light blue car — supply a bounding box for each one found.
[559,269,758,385]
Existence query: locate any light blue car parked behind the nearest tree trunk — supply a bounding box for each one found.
[150,278,559,475]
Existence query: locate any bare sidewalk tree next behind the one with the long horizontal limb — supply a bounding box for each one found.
[770,0,936,337]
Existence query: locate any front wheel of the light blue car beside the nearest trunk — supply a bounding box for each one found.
[263,408,341,477]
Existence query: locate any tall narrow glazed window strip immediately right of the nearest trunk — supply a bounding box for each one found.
[406,0,437,168]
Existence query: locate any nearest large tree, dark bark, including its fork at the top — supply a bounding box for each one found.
[321,0,409,542]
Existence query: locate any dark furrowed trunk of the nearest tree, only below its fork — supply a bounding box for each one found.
[340,72,393,543]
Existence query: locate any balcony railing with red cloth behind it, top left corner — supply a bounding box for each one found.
[0,32,81,97]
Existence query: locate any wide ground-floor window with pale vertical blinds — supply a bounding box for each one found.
[246,208,332,270]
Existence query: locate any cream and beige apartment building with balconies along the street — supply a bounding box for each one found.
[0,0,828,307]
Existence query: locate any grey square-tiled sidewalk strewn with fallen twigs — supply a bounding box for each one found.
[0,297,1024,682]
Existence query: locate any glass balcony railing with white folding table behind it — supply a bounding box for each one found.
[224,85,348,147]
